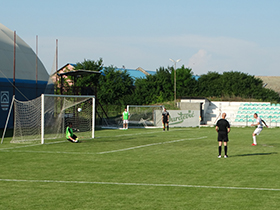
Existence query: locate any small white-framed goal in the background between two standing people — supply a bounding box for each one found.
[127,105,164,127]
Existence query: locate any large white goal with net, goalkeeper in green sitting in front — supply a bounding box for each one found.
[2,94,95,144]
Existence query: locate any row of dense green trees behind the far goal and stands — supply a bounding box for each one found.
[59,58,280,105]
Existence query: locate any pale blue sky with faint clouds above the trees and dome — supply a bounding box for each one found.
[0,0,280,76]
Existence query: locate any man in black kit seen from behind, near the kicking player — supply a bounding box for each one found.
[216,113,230,158]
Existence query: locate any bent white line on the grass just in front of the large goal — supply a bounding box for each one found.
[0,136,207,155]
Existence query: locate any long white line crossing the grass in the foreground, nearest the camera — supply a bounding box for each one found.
[0,179,280,191]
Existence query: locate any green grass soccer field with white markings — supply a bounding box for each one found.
[0,128,280,210]
